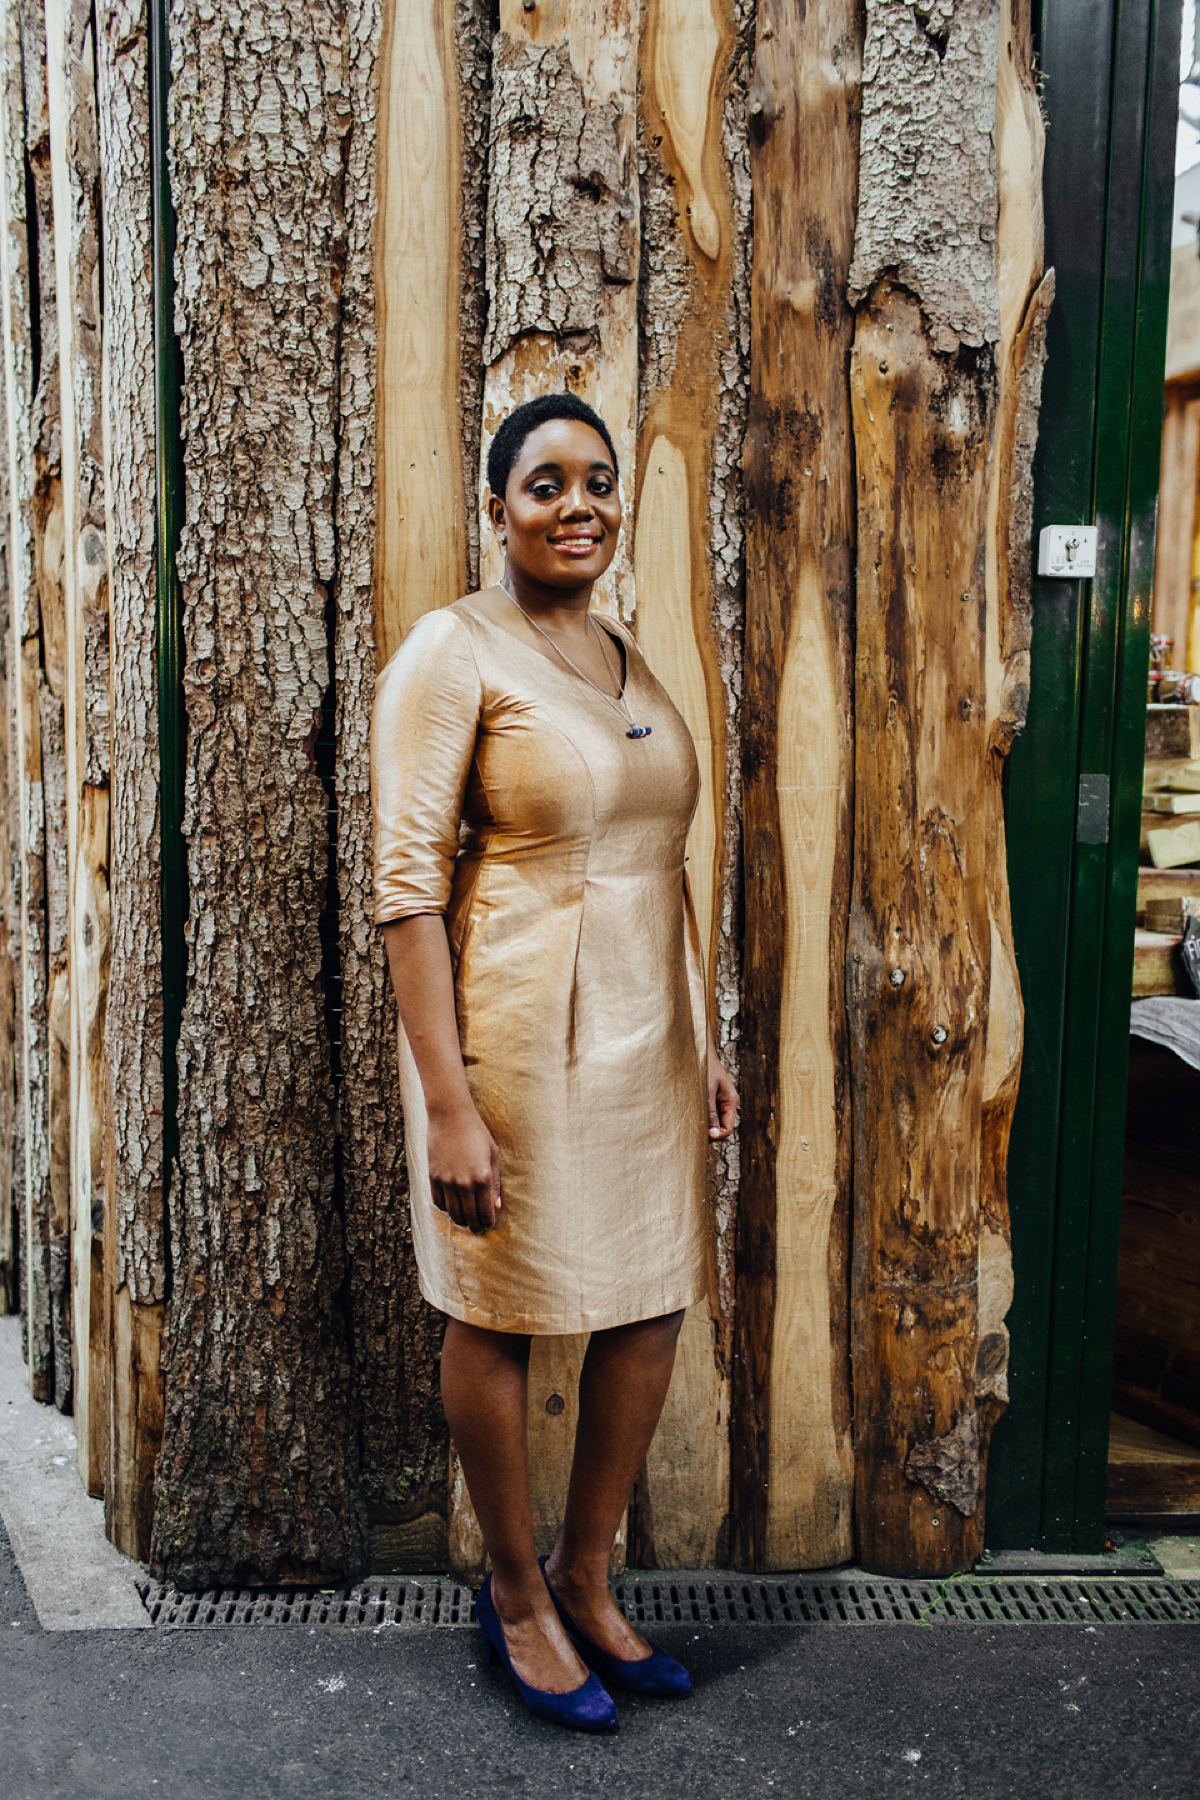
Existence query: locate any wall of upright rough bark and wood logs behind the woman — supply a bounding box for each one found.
[0,0,1052,1584]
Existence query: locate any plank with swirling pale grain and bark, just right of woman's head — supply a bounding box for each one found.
[631,0,748,1568]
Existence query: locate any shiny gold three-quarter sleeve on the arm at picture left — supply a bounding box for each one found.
[371,610,482,925]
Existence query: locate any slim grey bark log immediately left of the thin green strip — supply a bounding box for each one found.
[96,0,167,1561]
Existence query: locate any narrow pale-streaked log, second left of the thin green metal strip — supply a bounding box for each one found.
[45,0,108,1494]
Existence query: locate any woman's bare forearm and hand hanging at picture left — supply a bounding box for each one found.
[383,913,500,1233]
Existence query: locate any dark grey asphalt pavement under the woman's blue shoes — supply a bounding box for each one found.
[0,1530,1200,1800]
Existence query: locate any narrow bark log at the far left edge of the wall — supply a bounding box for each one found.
[0,0,54,1400]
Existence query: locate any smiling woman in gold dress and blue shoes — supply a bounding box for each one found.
[372,394,738,1730]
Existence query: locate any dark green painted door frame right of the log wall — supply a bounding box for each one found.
[988,0,1180,1552]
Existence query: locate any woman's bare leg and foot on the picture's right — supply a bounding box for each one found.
[547,1312,684,1661]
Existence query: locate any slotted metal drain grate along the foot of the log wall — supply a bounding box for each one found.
[142,1573,1200,1631]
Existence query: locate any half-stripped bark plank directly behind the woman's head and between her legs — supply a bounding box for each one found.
[450,0,640,1566]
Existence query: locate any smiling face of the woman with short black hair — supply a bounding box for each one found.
[488,419,621,589]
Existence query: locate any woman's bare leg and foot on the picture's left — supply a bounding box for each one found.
[441,1319,590,1694]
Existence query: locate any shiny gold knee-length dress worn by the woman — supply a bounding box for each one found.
[371,599,707,1336]
